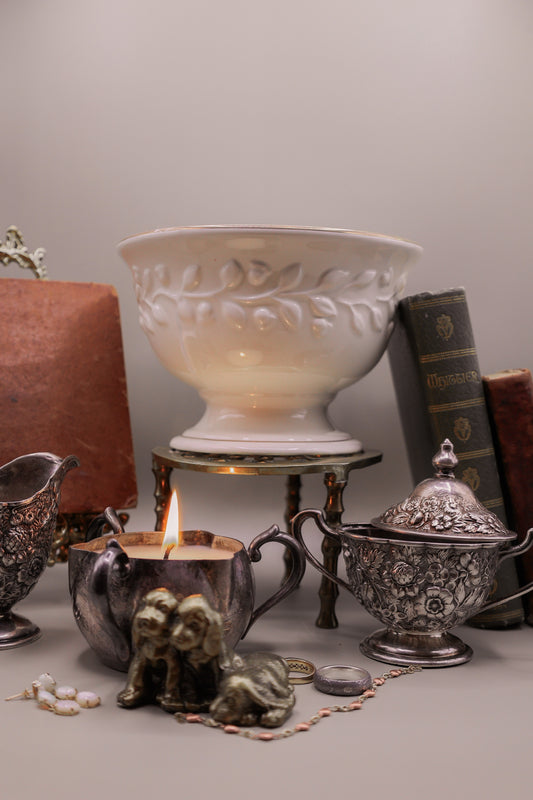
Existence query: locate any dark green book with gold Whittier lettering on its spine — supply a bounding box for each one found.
[388,288,524,628]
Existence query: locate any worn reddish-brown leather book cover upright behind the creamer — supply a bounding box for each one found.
[0,278,137,513]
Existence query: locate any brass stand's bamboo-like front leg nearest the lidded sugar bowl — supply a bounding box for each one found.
[316,472,347,628]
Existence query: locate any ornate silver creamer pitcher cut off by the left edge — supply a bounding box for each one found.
[0,453,79,649]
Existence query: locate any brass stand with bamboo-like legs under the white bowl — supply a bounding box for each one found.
[152,447,382,628]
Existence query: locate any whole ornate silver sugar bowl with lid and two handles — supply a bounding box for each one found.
[293,440,533,667]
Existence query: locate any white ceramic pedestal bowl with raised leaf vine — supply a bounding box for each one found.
[119,225,421,455]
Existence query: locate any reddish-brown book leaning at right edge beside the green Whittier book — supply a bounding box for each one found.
[483,369,533,625]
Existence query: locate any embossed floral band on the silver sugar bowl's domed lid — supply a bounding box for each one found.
[380,495,509,538]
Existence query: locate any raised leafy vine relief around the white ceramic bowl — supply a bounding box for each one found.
[133,259,405,337]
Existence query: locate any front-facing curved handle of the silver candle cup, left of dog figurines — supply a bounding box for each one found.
[90,536,131,668]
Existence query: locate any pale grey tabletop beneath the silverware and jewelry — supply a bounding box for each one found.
[0,564,533,800]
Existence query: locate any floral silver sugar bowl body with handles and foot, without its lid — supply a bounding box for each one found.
[293,509,533,667]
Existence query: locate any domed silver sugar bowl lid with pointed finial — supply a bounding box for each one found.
[372,439,516,543]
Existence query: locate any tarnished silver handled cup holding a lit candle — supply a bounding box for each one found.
[69,496,305,671]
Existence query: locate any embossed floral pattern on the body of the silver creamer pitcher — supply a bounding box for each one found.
[0,483,59,614]
